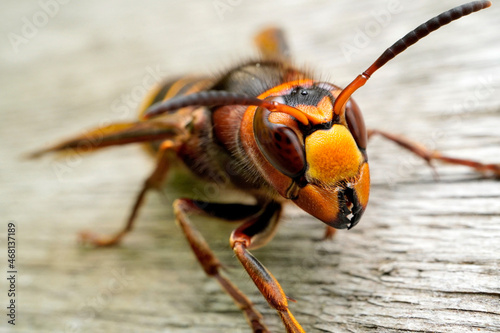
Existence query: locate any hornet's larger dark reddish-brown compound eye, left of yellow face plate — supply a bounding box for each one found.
[253,97,306,179]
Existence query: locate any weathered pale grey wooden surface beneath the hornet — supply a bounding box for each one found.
[0,0,500,333]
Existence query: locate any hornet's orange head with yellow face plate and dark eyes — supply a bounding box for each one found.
[241,80,370,229]
